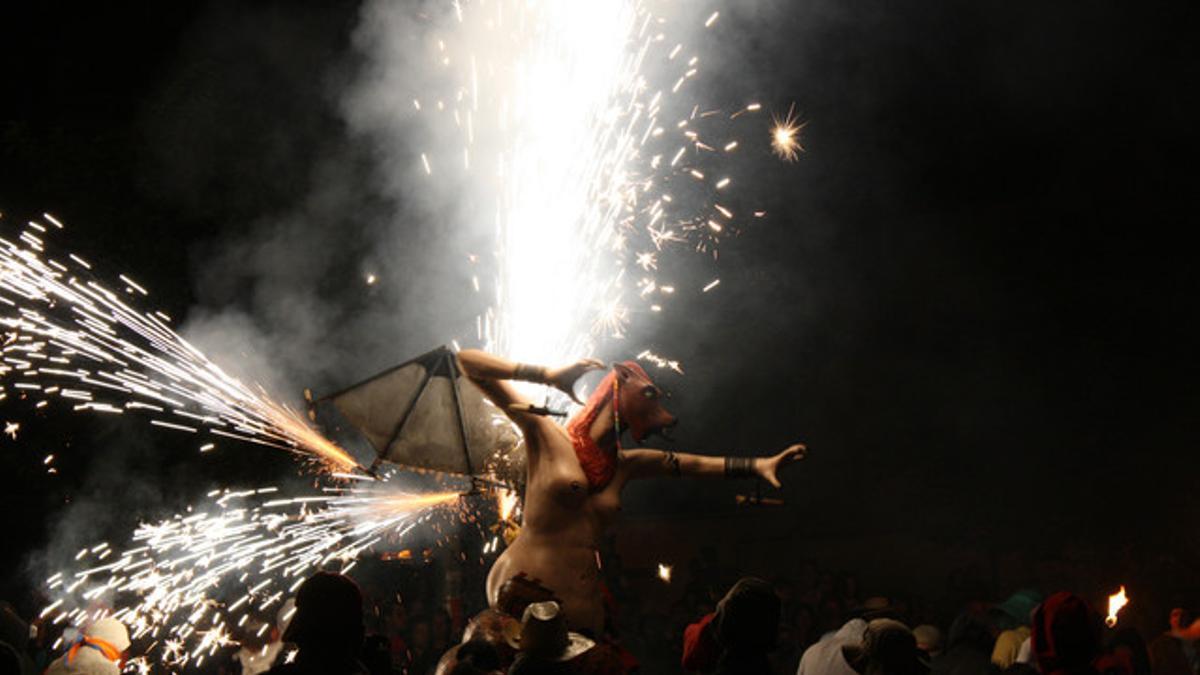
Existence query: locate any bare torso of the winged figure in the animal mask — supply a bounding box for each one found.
[487,420,625,637]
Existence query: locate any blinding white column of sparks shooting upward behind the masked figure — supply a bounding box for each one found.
[406,0,761,372]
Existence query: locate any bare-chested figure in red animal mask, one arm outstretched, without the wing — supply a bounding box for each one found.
[458,350,805,638]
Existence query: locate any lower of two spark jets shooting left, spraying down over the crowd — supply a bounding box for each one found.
[41,486,458,669]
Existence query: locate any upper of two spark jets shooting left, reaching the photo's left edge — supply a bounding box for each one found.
[0,216,358,470]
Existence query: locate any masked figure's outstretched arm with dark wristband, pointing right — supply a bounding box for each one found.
[620,443,808,488]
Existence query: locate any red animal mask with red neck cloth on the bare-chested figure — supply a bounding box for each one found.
[566,362,677,490]
